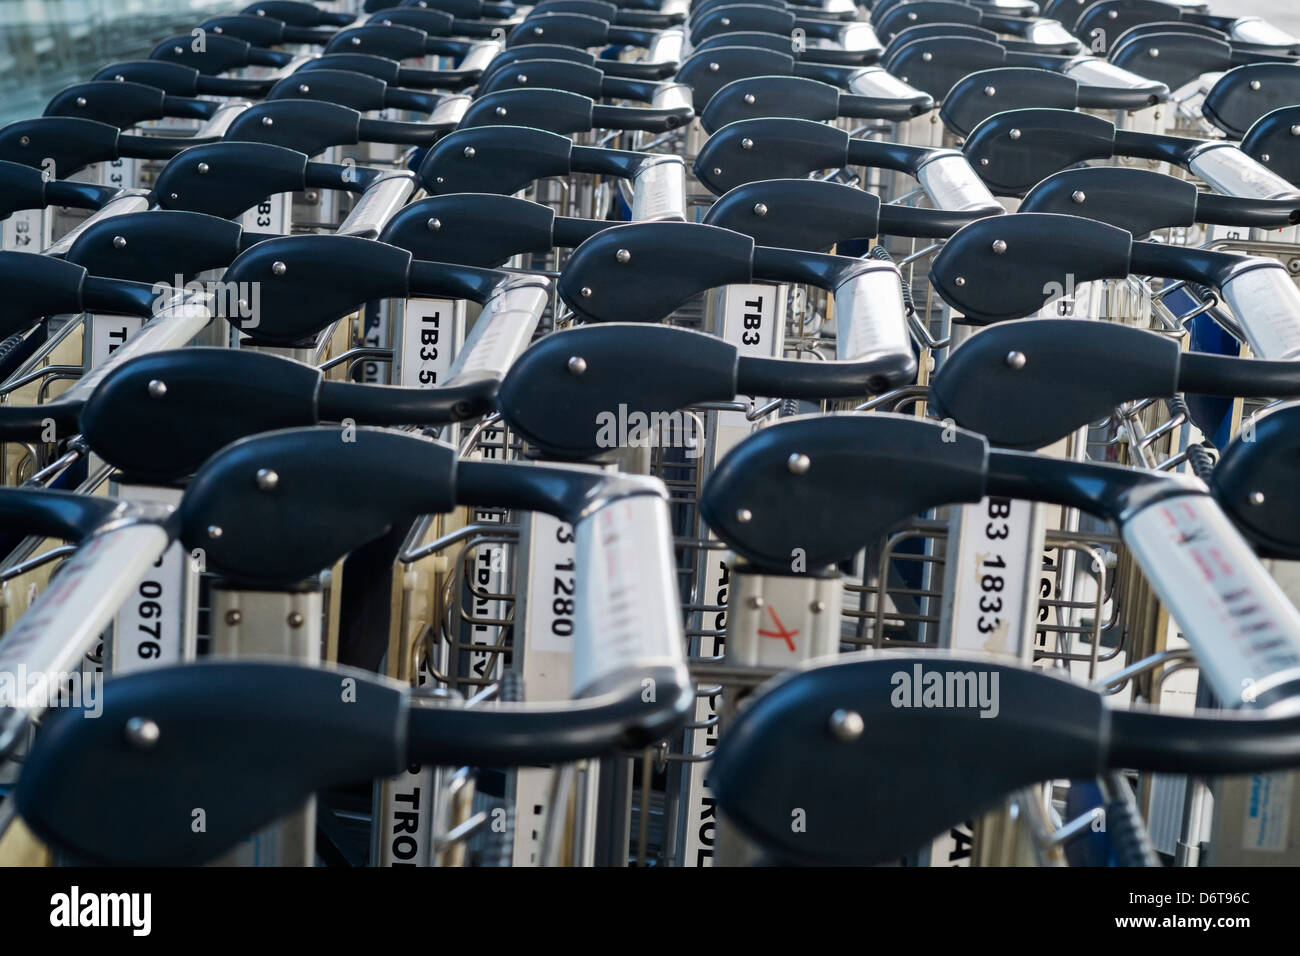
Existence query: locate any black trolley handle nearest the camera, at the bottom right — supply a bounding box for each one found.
[710,653,1300,865]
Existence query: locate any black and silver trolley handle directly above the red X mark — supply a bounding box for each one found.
[701,414,1300,708]
